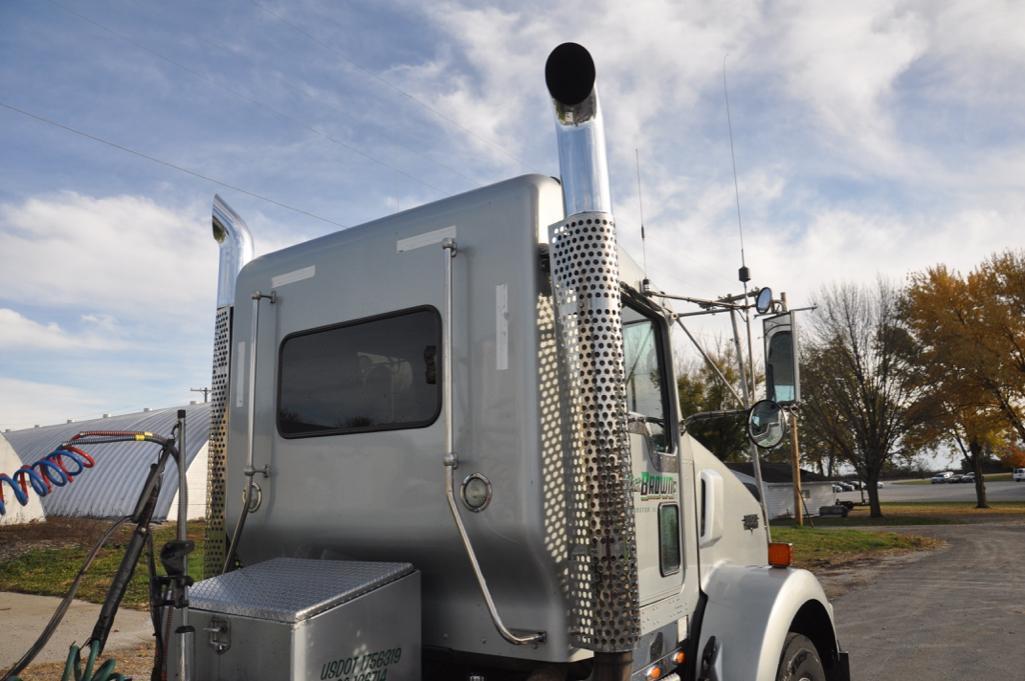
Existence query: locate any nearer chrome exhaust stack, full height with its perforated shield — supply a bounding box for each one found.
[544,43,641,668]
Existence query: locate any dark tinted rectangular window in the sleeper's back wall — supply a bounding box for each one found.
[278,307,442,438]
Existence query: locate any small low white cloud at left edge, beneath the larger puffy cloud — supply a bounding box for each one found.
[0,308,127,351]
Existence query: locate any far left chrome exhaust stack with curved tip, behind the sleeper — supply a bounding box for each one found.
[203,195,253,577]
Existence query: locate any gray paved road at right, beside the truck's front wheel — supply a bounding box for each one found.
[833,518,1025,681]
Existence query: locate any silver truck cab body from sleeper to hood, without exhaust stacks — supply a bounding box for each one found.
[218,175,848,678]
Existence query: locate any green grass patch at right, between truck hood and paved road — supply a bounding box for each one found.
[772,527,942,568]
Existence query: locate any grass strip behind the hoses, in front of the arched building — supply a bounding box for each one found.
[0,521,204,609]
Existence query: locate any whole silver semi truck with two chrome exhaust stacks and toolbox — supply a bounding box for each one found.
[182,43,850,681]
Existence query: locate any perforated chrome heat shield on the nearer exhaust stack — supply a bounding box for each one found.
[548,212,640,652]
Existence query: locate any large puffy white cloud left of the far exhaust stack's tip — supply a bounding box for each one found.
[0,192,217,320]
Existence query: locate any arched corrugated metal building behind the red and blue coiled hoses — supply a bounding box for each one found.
[0,404,210,520]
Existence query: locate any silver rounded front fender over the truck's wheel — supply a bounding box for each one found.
[696,564,843,681]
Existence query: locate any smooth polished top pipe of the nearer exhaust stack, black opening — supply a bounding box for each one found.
[544,43,612,217]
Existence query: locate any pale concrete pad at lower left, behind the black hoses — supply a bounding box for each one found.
[0,592,153,671]
